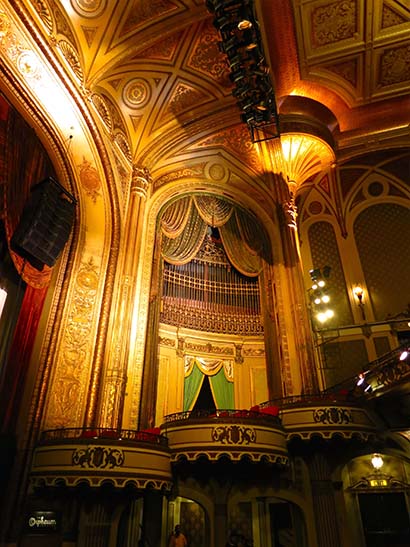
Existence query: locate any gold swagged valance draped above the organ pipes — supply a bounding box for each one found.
[161,195,272,277]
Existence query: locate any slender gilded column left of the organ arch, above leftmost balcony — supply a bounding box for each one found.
[98,166,151,428]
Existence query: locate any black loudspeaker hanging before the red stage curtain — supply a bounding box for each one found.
[10,177,76,271]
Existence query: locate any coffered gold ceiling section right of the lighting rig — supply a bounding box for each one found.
[293,0,410,106]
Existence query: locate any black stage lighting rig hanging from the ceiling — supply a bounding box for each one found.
[206,0,279,142]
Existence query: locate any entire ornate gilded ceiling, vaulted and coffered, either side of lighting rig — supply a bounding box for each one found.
[0,0,410,170]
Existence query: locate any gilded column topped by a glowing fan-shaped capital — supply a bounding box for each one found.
[261,119,334,395]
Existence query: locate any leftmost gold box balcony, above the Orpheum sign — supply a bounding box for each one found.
[30,428,171,490]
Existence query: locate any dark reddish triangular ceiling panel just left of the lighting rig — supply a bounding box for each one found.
[187,20,232,87]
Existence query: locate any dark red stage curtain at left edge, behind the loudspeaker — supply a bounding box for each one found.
[0,97,55,431]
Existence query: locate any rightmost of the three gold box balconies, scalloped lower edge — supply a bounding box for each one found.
[260,393,380,441]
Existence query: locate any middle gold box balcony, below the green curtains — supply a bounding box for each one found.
[161,410,288,465]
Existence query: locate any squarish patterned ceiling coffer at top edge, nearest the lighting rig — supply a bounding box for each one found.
[311,0,357,46]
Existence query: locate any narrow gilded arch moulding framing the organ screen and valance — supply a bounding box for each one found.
[133,181,281,428]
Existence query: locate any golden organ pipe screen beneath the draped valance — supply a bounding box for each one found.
[161,227,263,335]
